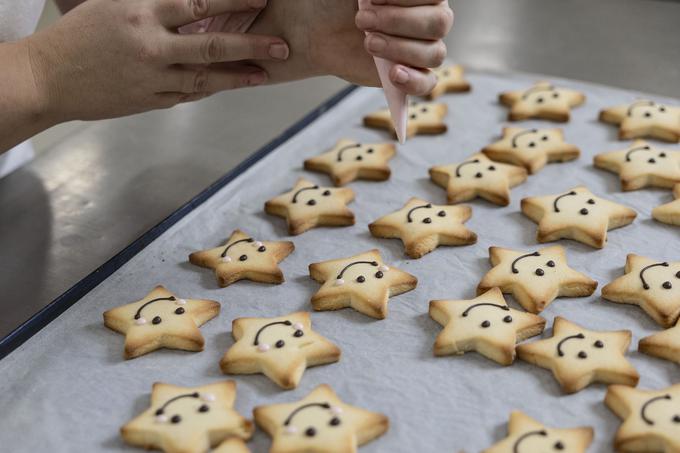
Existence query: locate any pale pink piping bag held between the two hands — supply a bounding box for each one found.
[179,0,408,143]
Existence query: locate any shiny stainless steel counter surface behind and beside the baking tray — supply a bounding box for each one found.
[0,0,680,346]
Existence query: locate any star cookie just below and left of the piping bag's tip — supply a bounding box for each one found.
[305,139,396,186]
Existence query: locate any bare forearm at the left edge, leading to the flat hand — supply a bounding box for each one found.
[0,40,53,154]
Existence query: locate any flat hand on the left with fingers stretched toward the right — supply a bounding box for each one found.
[25,0,289,122]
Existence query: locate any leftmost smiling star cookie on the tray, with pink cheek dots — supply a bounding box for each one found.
[104,286,220,359]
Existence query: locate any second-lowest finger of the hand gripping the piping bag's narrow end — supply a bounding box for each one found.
[364,33,446,68]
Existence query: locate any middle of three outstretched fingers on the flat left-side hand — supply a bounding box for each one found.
[165,33,290,64]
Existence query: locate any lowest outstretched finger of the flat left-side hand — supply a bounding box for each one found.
[165,64,268,94]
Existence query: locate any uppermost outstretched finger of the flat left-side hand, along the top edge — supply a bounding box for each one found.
[155,0,267,28]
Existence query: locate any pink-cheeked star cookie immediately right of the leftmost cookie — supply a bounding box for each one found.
[220,312,340,389]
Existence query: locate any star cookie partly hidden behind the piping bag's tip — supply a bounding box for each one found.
[364,102,448,137]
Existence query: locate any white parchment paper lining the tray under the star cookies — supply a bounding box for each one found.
[0,69,680,453]
